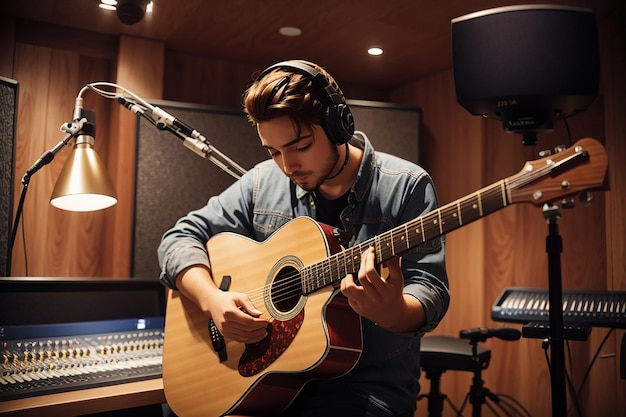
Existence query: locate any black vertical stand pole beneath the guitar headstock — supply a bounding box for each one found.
[543,204,567,417]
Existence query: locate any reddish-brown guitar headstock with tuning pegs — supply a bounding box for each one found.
[505,138,608,205]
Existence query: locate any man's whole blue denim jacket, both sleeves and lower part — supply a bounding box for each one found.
[158,132,450,413]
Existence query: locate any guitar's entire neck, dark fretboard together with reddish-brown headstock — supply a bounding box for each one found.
[301,138,607,295]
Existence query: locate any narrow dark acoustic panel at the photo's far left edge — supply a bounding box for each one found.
[0,77,18,275]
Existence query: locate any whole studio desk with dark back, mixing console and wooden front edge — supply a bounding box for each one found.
[0,277,165,417]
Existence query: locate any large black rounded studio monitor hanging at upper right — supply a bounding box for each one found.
[451,5,600,141]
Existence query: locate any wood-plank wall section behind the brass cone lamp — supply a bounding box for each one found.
[13,44,114,276]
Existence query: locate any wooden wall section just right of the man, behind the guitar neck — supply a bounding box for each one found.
[392,71,488,410]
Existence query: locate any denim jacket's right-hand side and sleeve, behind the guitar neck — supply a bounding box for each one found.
[342,132,450,334]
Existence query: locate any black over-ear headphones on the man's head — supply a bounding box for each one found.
[257,61,354,145]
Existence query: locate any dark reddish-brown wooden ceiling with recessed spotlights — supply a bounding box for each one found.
[0,0,622,88]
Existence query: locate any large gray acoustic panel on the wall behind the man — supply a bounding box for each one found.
[132,101,421,279]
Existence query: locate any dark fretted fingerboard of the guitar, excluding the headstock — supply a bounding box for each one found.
[301,180,510,295]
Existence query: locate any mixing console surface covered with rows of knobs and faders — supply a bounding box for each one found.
[0,317,164,401]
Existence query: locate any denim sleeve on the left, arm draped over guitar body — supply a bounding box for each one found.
[158,160,311,289]
